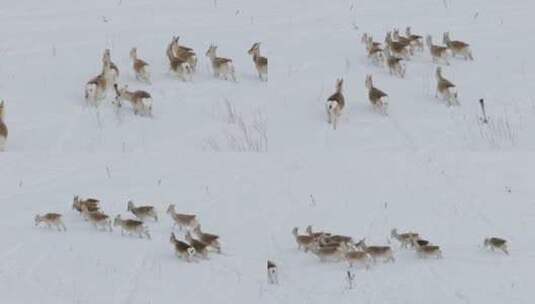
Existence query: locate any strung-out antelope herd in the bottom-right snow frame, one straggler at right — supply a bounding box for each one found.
[292,225,509,269]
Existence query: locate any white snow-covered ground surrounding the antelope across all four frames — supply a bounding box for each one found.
[0,0,535,303]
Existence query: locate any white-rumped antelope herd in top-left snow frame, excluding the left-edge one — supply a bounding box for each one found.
[85,36,268,116]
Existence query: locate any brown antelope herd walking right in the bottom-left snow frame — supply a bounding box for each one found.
[35,196,221,262]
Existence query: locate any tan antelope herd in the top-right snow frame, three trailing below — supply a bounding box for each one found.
[326,27,474,129]
